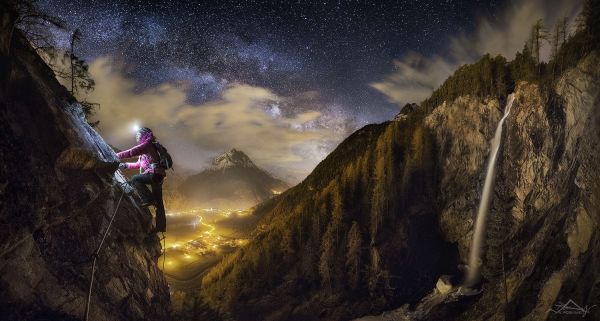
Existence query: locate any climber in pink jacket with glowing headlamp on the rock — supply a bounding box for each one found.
[117,127,170,232]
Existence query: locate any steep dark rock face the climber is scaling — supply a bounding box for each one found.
[0,34,170,320]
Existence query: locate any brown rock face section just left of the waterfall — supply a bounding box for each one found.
[426,96,502,259]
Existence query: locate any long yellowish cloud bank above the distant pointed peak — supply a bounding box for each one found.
[88,58,351,182]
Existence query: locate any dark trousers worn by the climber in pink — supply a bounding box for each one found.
[131,173,167,232]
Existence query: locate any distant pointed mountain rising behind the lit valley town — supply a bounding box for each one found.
[179,148,289,208]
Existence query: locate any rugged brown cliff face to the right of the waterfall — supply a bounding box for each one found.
[450,53,600,320]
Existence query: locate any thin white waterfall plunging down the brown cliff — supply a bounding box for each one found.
[465,94,515,286]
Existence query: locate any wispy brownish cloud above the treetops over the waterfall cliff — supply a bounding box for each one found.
[371,0,581,106]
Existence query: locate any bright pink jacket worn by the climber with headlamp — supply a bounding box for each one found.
[117,133,166,176]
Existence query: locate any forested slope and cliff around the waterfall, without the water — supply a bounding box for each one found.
[200,8,600,320]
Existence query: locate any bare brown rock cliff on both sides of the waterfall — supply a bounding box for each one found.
[427,54,600,320]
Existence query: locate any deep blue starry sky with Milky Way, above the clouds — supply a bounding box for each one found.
[42,0,506,122]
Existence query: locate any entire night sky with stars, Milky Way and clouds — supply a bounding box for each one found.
[40,0,579,182]
